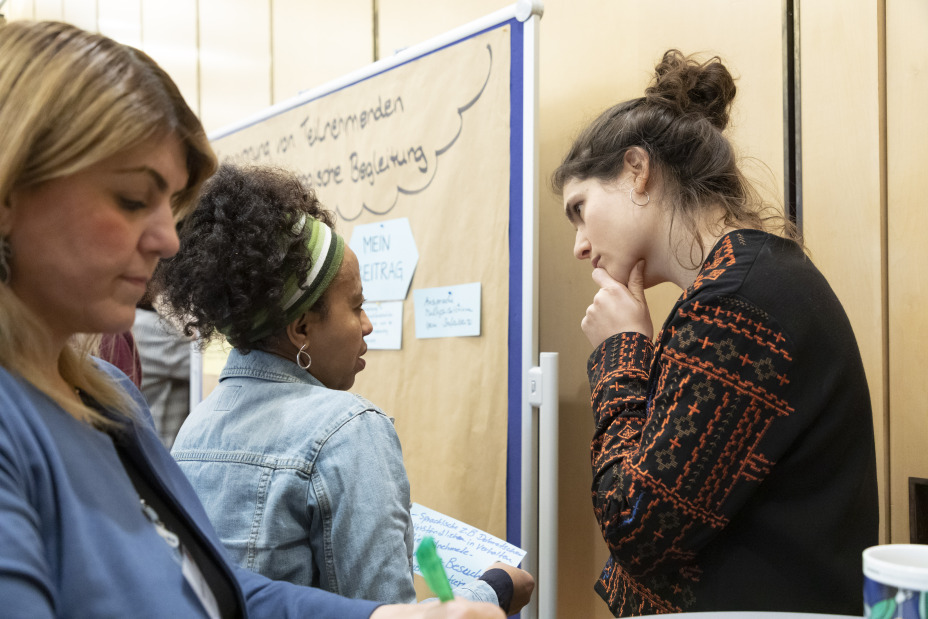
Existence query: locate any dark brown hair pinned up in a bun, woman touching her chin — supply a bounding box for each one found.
[551,49,799,265]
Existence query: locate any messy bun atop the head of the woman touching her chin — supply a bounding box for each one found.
[645,49,736,130]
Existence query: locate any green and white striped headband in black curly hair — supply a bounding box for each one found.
[236,214,345,343]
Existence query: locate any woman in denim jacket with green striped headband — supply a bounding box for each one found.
[155,165,533,613]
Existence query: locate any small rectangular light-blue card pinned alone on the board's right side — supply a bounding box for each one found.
[413,282,480,338]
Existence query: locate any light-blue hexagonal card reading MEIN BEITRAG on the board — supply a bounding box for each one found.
[348,217,419,301]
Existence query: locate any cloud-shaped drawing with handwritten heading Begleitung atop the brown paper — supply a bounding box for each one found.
[213,31,509,222]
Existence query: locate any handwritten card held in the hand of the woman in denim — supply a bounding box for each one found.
[411,503,525,587]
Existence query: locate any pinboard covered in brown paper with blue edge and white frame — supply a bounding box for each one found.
[194,1,541,600]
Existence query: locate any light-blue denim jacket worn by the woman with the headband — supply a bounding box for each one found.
[171,350,497,604]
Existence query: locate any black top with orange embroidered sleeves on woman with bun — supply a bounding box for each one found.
[588,230,878,616]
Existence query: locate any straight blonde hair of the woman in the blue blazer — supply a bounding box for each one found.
[0,21,216,427]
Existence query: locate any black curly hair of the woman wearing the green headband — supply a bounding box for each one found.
[152,164,335,352]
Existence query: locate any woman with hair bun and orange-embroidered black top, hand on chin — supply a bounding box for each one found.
[553,50,878,616]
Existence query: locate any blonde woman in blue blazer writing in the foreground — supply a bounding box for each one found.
[0,22,502,619]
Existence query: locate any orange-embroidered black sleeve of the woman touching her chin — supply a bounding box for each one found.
[588,298,796,577]
